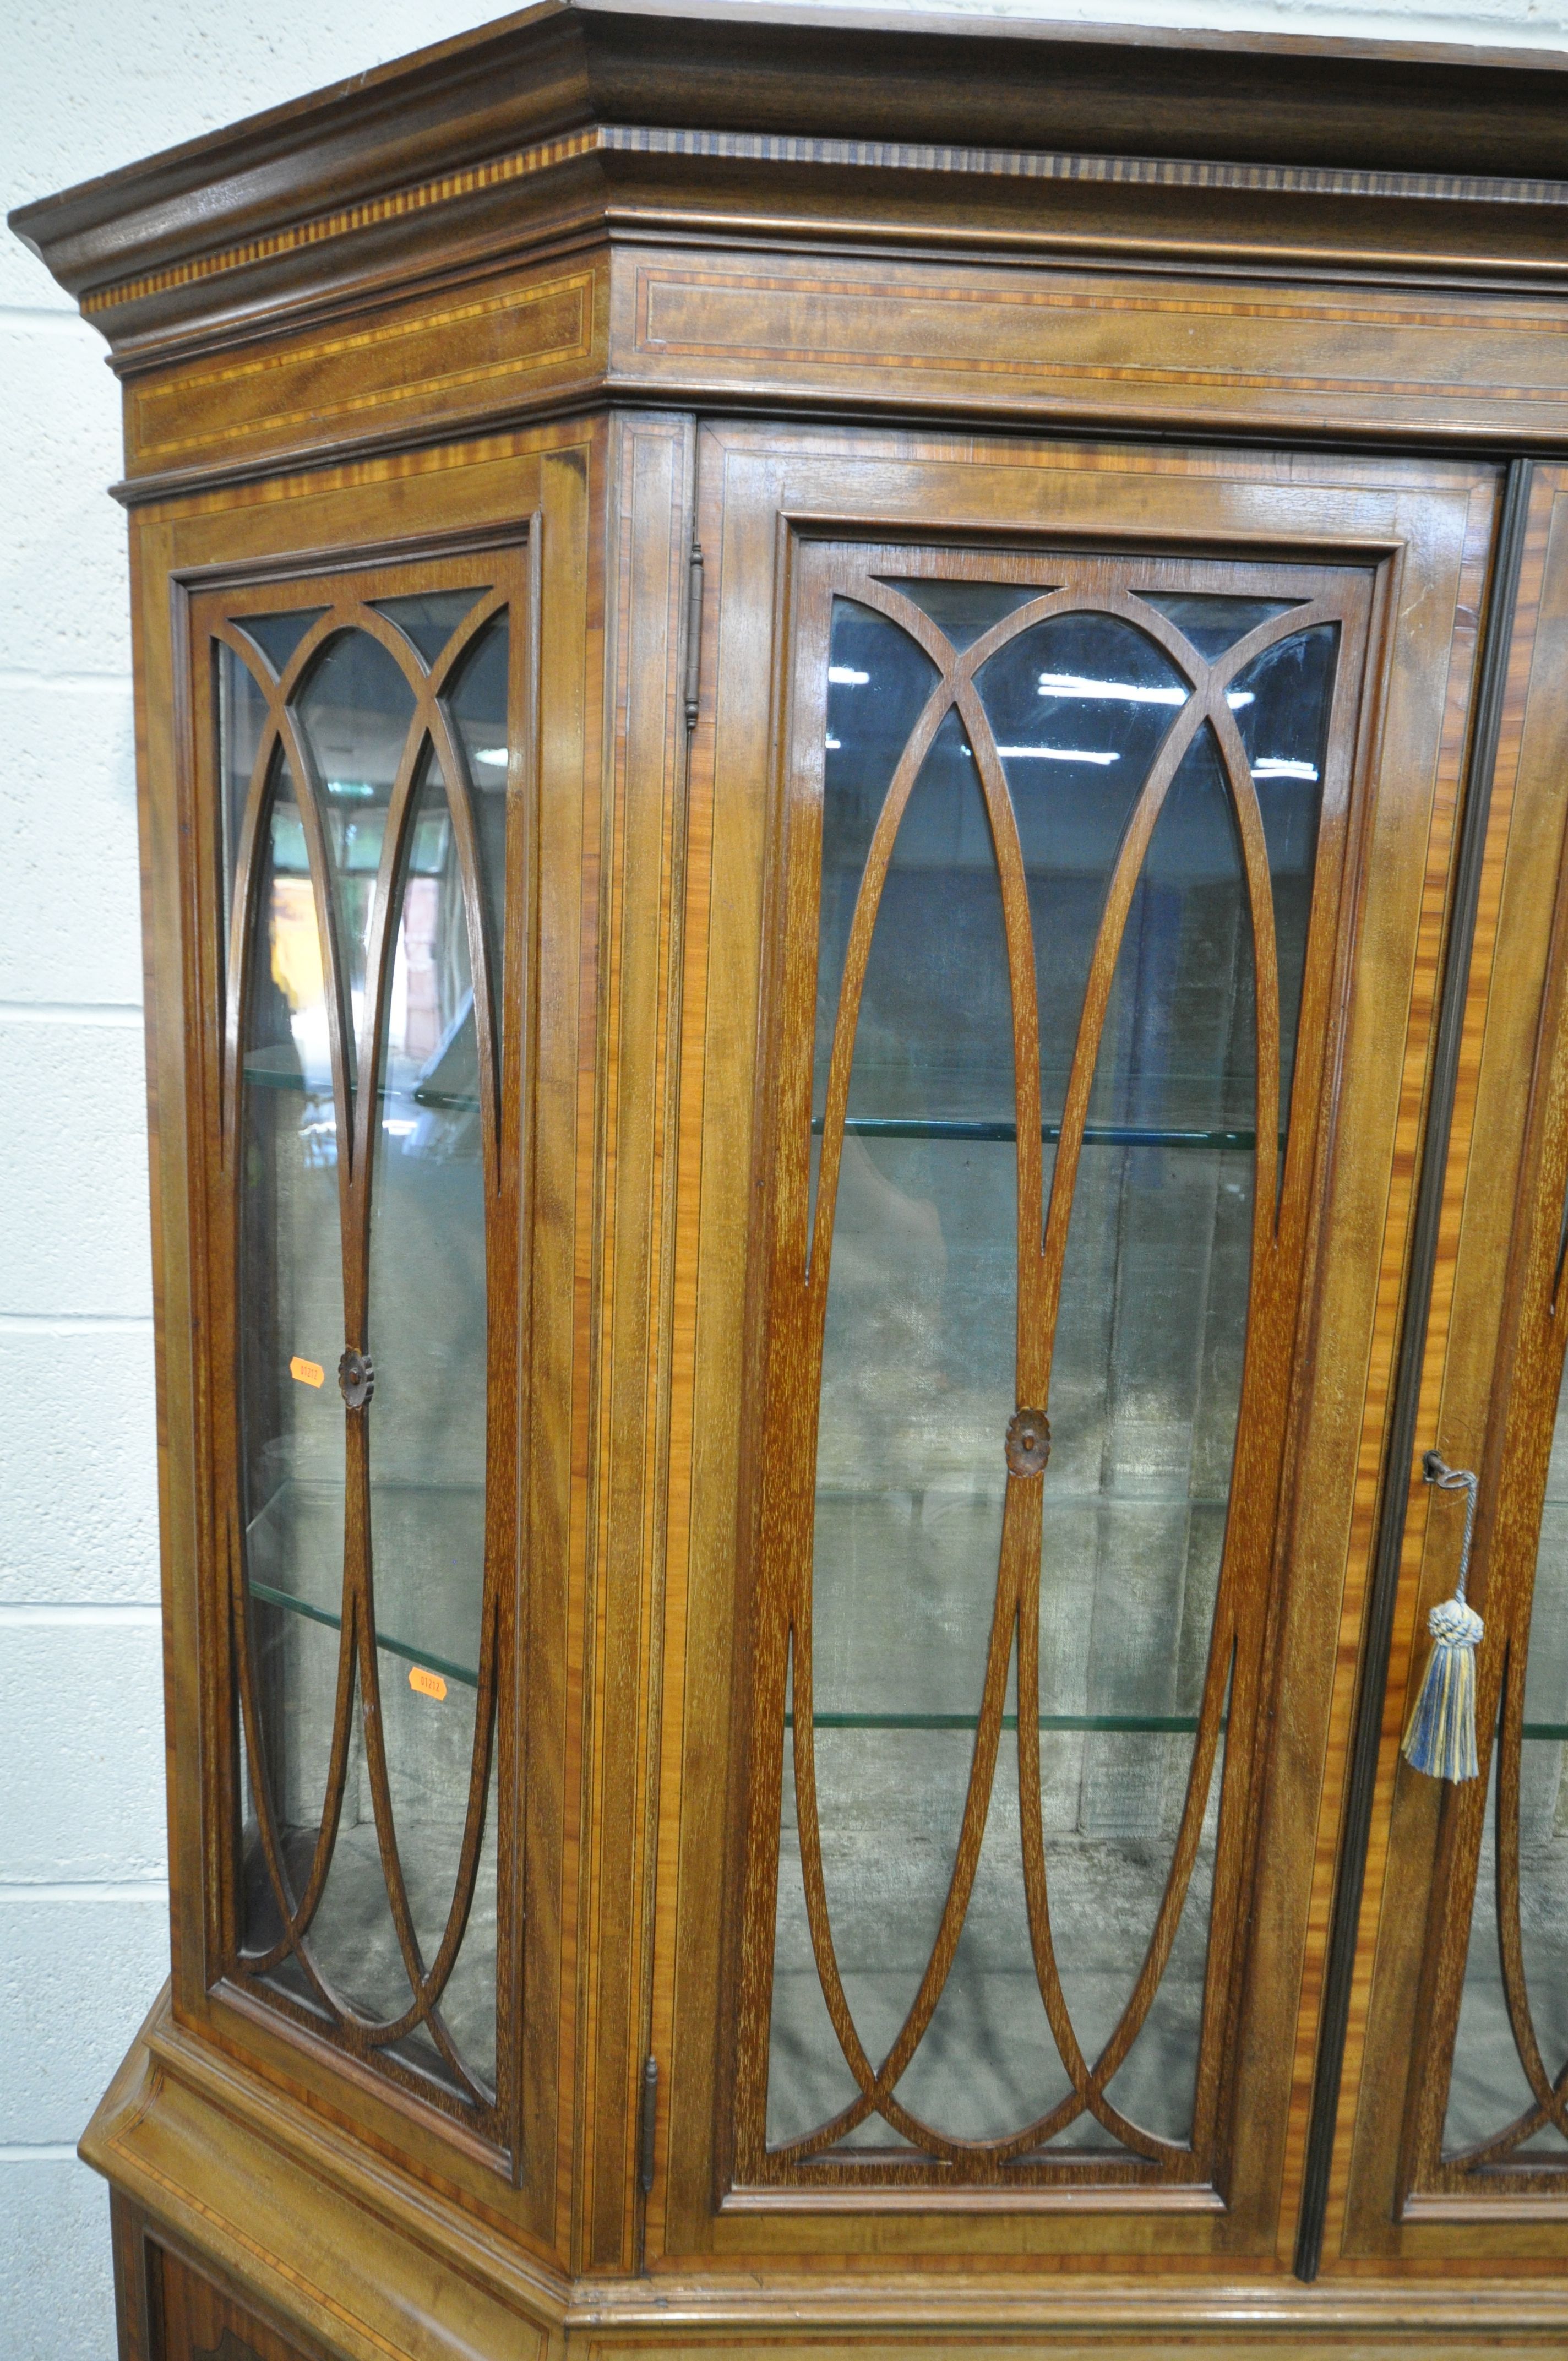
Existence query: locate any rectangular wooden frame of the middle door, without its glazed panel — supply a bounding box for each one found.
[650,425,1497,2269]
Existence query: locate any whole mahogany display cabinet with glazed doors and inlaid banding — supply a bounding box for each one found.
[14,0,1568,2361]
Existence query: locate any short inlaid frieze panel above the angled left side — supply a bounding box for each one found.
[125,264,605,479]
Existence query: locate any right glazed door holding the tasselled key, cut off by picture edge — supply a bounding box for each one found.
[1325,467,1568,2271]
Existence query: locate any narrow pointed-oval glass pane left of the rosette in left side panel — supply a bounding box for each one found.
[238,763,345,1948]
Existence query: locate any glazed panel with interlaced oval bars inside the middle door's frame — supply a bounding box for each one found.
[737,550,1363,2184]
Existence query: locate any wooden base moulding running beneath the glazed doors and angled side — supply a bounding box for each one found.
[83,1993,1568,2361]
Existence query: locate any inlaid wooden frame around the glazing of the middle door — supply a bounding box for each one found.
[650,427,1495,2269]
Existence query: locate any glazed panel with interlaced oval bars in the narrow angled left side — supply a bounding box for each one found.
[213,557,524,2137]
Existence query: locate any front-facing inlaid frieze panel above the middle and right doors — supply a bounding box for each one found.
[609,253,1568,439]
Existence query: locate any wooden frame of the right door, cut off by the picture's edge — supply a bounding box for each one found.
[1325,463,1568,2273]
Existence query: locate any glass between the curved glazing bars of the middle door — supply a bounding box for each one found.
[767,567,1334,2161]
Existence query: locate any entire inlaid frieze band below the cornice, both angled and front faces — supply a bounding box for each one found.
[107,229,1568,498]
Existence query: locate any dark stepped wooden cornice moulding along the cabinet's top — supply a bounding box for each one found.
[12,0,1568,366]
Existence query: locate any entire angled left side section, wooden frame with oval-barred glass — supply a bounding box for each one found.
[139,429,597,2243]
